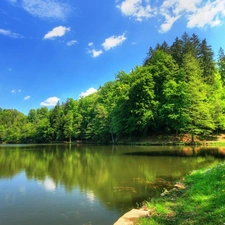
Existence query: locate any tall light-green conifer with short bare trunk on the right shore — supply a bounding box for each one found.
[183,54,215,141]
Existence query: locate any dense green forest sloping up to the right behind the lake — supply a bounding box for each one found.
[0,33,225,143]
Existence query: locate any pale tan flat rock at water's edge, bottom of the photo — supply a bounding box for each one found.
[114,209,149,225]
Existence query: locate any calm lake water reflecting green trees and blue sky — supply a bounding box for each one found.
[0,145,225,225]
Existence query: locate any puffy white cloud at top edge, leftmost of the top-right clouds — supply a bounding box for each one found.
[117,0,155,21]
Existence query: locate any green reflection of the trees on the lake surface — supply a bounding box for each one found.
[0,145,221,210]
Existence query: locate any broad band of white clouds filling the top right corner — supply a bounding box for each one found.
[116,0,225,33]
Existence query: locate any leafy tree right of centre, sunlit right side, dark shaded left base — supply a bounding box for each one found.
[126,67,157,134]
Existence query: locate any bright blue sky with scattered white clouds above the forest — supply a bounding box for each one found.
[0,0,225,114]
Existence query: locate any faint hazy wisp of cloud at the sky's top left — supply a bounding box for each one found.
[21,0,71,20]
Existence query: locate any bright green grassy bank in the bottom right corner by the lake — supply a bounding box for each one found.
[136,164,225,225]
